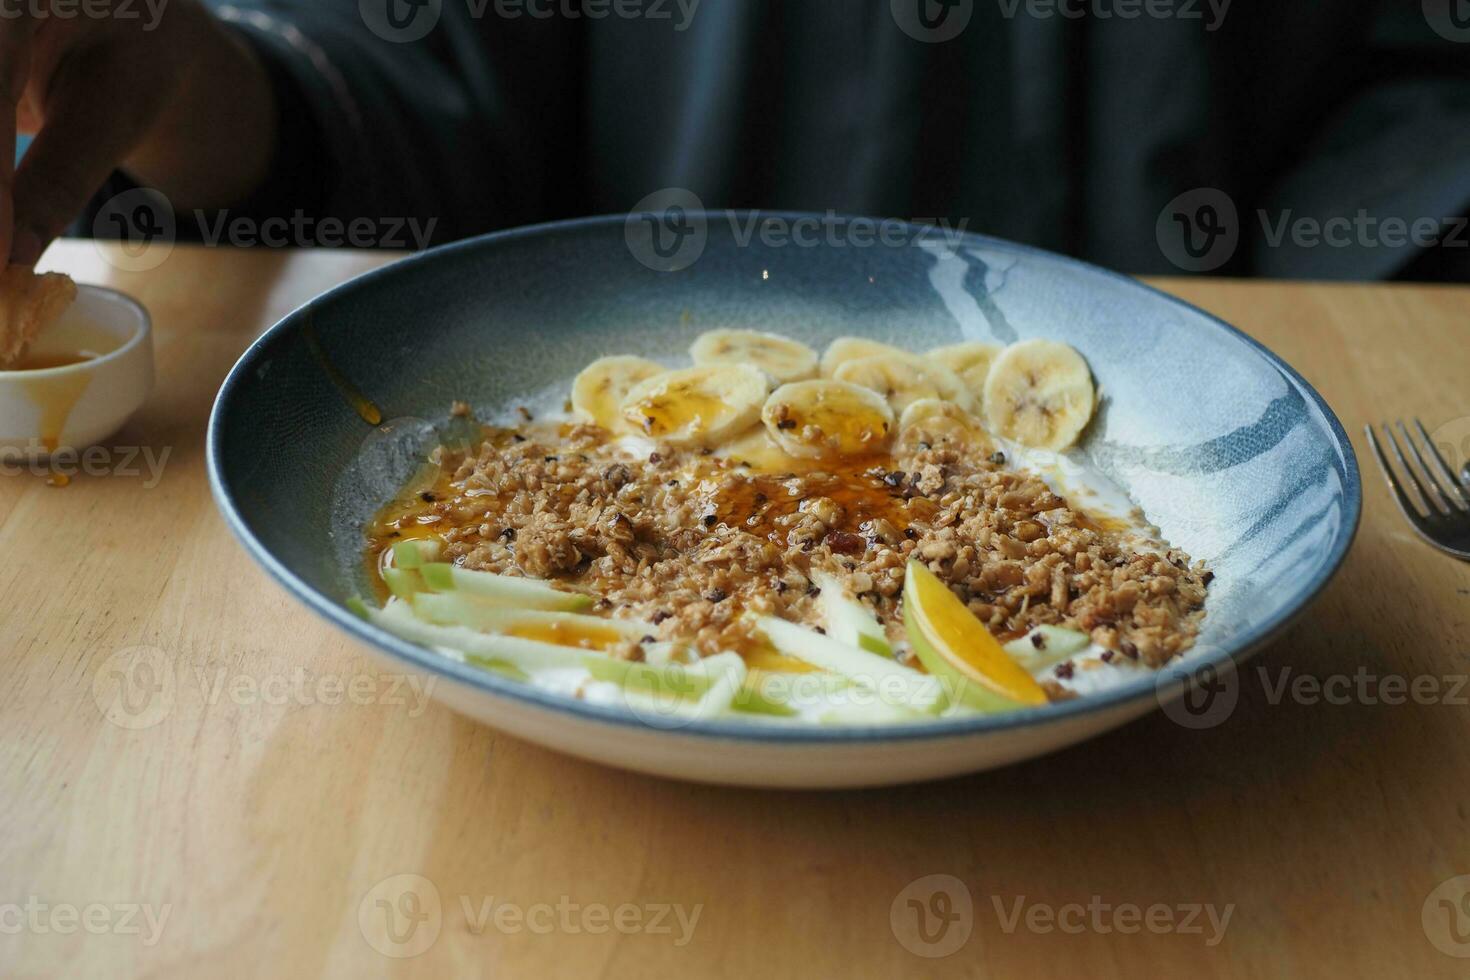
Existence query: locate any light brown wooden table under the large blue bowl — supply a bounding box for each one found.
[0,242,1470,979]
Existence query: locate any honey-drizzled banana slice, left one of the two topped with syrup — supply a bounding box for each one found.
[622,364,770,447]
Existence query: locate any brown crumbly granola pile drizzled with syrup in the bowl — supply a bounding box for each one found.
[370,423,1210,687]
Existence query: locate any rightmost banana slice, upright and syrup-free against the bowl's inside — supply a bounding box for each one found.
[985,339,1097,453]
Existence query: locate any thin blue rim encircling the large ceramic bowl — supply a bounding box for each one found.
[204,210,1363,748]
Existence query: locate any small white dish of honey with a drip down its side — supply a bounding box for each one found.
[0,285,153,460]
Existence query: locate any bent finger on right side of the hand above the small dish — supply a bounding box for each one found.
[12,43,161,262]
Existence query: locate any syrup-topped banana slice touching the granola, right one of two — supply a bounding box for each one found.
[760,379,894,458]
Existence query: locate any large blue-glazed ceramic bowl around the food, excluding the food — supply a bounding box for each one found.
[209,213,1361,786]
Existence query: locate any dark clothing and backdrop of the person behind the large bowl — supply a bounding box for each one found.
[71,0,1470,282]
